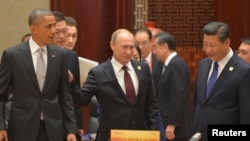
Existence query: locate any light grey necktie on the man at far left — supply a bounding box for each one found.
[36,48,47,91]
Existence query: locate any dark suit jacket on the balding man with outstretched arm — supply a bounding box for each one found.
[71,60,159,141]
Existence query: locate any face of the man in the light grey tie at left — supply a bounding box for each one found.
[30,16,56,46]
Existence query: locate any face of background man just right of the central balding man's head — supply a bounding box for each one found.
[135,32,152,59]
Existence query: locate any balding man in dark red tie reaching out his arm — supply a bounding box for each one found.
[70,29,159,141]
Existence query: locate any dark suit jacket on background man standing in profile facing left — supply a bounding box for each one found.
[156,55,191,139]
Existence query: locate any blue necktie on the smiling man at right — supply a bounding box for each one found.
[206,62,218,98]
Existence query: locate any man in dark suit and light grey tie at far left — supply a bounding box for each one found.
[0,9,77,141]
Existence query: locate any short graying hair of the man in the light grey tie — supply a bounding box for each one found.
[29,8,53,25]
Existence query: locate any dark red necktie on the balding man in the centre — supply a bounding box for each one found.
[122,66,135,104]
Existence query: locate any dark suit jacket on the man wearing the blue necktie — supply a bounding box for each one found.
[193,54,250,141]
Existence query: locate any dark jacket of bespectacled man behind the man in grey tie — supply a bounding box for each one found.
[65,48,83,129]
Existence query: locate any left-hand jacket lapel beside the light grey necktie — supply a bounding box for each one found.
[21,42,40,91]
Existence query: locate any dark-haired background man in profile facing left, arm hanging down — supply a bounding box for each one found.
[153,32,190,141]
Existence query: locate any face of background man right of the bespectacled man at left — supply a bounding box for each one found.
[64,26,77,50]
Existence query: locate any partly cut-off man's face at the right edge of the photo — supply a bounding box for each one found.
[238,43,250,63]
